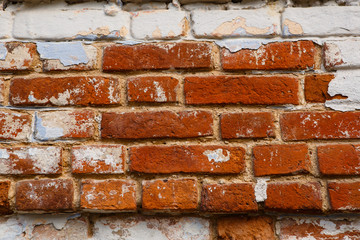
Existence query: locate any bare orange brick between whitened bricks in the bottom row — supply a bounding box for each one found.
[217,216,275,240]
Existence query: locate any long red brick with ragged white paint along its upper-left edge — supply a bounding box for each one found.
[221,41,315,70]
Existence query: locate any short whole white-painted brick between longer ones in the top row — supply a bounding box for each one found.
[131,10,188,39]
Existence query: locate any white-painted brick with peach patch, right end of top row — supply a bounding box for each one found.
[282,6,360,36]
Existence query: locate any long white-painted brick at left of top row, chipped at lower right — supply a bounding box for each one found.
[13,7,130,40]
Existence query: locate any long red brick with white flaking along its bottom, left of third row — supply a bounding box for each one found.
[10,77,120,106]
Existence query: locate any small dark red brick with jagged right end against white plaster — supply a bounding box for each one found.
[304,74,334,103]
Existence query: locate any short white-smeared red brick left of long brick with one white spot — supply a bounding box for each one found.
[71,145,126,174]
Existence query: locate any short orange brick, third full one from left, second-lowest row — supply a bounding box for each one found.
[142,179,199,210]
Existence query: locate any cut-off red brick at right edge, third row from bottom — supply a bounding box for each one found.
[317,144,360,175]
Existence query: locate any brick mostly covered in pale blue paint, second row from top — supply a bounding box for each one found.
[36,42,97,71]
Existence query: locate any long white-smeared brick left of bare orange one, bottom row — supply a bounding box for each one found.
[93,216,211,240]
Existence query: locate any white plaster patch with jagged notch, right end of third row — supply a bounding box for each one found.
[325,71,360,111]
